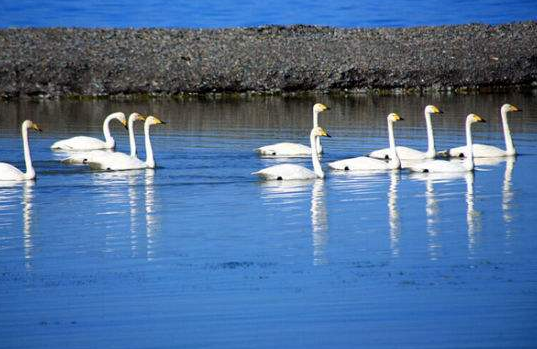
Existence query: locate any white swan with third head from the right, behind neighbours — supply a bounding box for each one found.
[369,105,443,160]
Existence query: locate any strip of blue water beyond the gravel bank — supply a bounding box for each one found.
[0,0,537,28]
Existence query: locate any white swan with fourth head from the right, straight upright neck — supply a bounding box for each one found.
[328,113,403,171]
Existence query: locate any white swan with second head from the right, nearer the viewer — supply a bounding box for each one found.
[409,114,486,172]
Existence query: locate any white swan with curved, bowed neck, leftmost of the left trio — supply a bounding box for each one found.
[50,112,127,150]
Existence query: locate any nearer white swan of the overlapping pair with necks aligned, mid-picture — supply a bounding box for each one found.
[252,126,330,180]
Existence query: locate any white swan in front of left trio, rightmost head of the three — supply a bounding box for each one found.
[88,116,165,171]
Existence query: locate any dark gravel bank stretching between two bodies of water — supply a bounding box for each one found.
[0,21,537,98]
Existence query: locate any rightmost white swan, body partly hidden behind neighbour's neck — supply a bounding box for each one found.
[440,104,522,158]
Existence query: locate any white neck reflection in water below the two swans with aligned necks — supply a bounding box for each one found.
[311,179,328,265]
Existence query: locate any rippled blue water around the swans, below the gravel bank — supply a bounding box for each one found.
[0,94,537,349]
